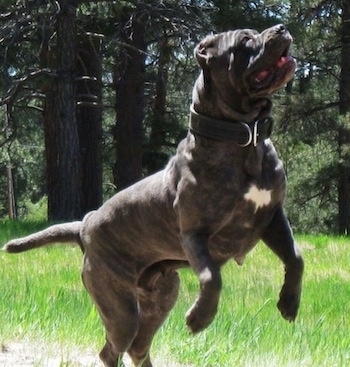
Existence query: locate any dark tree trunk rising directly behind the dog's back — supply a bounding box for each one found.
[114,14,146,190]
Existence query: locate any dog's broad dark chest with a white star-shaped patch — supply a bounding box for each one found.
[175,137,285,263]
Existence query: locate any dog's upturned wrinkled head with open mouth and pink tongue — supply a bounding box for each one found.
[195,25,296,97]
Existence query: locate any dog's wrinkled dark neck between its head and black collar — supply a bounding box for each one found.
[192,74,272,123]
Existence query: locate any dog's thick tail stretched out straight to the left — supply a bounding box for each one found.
[2,221,84,253]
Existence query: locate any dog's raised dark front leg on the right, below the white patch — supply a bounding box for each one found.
[262,208,304,321]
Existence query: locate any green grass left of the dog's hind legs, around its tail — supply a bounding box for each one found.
[0,222,102,345]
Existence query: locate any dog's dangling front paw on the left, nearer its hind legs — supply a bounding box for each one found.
[186,298,217,333]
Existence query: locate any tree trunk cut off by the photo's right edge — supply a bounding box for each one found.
[338,0,350,235]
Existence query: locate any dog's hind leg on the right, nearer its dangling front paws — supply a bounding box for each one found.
[128,268,179,367]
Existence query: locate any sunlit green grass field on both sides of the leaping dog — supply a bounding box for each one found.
[0,222,350,367]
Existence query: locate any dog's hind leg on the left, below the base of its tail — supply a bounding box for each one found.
[82,254,139,367]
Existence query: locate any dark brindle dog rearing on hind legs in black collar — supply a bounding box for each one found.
[3,25,304,367]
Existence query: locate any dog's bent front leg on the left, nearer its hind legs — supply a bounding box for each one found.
[181,231,221,333]
